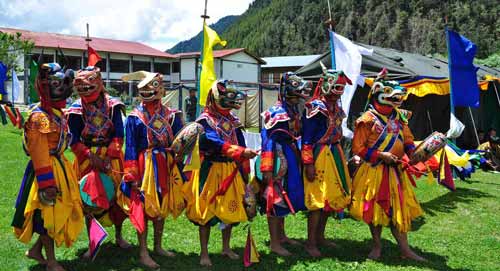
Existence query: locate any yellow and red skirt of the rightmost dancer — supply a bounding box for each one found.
[350,163,423,232]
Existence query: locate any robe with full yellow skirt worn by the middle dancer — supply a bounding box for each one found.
[183,111,250,225]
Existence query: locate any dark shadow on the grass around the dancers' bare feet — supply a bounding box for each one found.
[30,239,468,271]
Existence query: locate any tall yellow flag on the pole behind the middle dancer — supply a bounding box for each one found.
[200,23,226,106]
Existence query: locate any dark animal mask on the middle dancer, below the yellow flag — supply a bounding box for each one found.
[212,80,245,110]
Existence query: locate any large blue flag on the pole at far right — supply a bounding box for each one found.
[446,29,479,107]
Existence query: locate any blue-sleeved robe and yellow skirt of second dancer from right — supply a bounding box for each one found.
[302,98,351,211]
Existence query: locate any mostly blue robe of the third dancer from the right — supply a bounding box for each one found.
[260,101,306,216]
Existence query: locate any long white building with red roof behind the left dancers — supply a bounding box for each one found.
[0,27,265,108]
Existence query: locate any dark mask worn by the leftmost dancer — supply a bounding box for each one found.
[40,63,75,102]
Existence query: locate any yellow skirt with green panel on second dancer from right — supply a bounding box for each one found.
[303,144,351,211]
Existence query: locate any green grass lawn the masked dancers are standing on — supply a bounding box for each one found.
[0,124,500,271]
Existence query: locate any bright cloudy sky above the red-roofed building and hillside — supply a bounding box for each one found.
[0,0,253,51]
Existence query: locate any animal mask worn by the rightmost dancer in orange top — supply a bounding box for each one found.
[370,80,407,108]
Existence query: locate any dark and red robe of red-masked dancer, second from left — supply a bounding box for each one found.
[66,94,126,225]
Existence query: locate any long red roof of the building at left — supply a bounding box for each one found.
[0,27,175,58]
